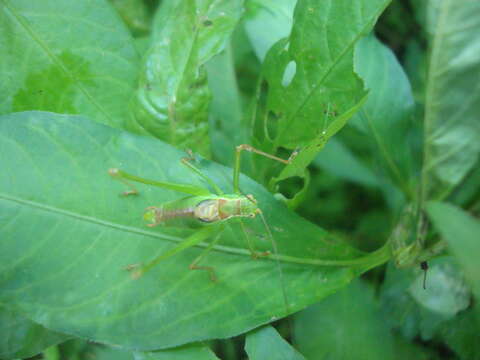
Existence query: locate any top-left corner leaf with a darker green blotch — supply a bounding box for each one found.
[0,0,139,128]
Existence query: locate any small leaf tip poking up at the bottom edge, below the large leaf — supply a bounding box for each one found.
[245,326,305,360]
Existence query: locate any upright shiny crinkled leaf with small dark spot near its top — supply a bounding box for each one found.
[128,0,242,155]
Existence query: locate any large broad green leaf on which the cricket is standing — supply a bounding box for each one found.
[0,112,389,350]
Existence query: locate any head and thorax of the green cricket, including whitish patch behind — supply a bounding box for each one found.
[194,197,258,222]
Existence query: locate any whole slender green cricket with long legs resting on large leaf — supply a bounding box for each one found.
[108,144,297,281]
